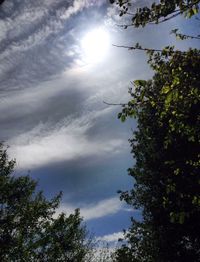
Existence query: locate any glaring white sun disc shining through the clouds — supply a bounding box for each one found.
[81,28,110,63]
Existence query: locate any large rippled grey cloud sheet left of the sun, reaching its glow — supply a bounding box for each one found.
[0,0,104,90]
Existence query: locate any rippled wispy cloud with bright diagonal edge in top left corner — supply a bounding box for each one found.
[0,0,94,54]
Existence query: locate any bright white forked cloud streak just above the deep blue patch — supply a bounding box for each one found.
[7,108,124,169]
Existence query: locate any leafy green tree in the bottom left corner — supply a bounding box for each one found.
[0,144,91,262]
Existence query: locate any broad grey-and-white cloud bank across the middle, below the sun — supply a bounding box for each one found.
[0,58,132,169]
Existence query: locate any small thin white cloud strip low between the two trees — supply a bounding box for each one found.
[56,197,123,221]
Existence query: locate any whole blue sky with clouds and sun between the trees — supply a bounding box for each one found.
[0,0,199,242]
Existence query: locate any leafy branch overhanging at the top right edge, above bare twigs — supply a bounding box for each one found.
[110,0,200,27]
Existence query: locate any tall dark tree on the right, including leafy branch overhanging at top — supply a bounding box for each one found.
[109,0,200,262]
